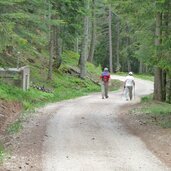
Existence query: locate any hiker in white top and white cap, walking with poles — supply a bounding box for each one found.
[124,72,135,100]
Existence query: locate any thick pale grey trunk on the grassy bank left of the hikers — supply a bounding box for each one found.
[80,0,89,78]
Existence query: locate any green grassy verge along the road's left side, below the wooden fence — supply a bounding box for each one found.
[0,74,100,111]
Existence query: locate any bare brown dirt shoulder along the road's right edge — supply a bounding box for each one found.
[120,104,171,167]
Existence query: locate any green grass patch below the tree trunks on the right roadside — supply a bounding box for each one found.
[140,95,171,128]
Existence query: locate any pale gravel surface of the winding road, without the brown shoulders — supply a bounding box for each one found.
[43,77,169,171]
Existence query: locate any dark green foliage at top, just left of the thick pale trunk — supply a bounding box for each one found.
[50,0,85,50]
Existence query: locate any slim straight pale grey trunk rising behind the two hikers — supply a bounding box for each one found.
[109,5,113,73]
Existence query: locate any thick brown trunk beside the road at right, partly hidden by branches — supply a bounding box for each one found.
[153,12,162,101]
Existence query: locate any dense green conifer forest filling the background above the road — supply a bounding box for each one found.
[0,0,171,103]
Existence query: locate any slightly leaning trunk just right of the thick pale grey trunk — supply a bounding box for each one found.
[87,0,96,62]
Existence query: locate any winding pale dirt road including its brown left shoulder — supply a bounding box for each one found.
[1,77,171,171]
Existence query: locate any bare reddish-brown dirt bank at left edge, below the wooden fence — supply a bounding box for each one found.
[0,100,22,134]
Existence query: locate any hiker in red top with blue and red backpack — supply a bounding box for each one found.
[100,68,110,99]
